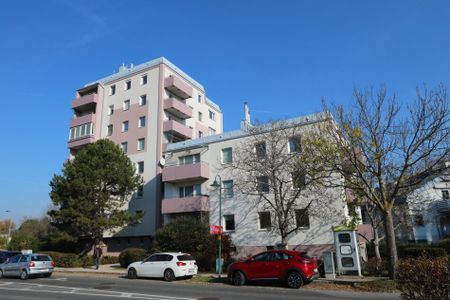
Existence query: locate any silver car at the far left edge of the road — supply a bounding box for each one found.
[0,254,55,280]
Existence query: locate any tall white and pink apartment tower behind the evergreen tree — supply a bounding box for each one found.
[68,57,223,251]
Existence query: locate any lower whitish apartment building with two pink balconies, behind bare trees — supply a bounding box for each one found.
[162,111,358,256]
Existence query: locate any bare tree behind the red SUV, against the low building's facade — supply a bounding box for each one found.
[224,115,340,247]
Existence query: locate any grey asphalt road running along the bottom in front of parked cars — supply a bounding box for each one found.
[0,274,400,300]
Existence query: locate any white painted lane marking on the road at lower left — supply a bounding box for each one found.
[0,282,195,300]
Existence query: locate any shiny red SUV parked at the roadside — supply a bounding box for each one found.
[228,250,319,289]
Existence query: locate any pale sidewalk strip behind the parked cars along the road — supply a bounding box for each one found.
[55,264,383,284]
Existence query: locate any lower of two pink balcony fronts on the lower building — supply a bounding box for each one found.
[161,196,209,214]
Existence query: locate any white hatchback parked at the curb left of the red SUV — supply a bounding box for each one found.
[127,252,198,281]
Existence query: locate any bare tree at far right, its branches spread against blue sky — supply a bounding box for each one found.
[316,86,450,278]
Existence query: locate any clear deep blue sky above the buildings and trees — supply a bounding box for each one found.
[0,0,450,225]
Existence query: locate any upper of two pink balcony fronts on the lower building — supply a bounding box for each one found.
[162,163,209,183]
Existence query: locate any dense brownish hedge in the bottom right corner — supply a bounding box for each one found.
[397,257,450,300]
